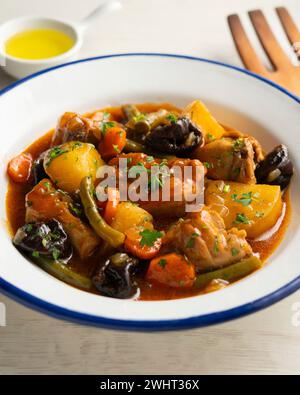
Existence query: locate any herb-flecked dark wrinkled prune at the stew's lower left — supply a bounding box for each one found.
[13,219,73,262]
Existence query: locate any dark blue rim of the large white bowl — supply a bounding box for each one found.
[0,53,300,331]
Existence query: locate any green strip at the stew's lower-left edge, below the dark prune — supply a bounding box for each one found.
[35,256,92,290]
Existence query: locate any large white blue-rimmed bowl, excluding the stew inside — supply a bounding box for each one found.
[0,54,300,330]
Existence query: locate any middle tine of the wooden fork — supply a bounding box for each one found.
[249,10,291,70]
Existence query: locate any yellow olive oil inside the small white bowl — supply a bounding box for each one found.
[5,29,75,60]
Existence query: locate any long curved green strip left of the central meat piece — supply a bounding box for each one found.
[80,177,125,248]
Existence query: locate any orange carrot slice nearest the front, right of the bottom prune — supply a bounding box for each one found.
[146,253,196,288]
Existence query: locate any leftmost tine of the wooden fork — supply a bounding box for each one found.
[228,14,267,75]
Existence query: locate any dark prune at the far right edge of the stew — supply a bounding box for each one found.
[255,145,294,189]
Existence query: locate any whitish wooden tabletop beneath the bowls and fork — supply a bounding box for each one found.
[0,0,300,375]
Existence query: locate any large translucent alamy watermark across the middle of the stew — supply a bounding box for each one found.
[96,157,205,213]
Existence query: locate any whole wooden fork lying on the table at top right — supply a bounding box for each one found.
[228,7,300,96]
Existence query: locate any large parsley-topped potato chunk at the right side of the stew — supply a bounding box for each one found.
[205,181,283,239]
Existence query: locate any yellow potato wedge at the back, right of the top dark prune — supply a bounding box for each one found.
[183,100,225,143]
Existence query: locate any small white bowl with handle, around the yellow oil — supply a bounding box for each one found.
[0,0,121,79]
